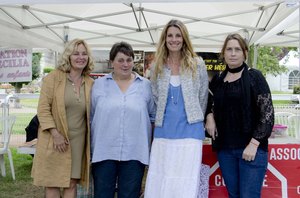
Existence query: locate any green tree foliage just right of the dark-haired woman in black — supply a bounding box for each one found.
[249,46,297,76]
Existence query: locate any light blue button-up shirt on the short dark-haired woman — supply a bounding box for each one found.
[91,73,155,165]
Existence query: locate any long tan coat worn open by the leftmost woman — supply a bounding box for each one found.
[31,70,93,188]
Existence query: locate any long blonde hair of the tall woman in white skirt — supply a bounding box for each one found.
[153,19,197,79]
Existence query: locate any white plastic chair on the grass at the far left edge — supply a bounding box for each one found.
[0,116,16,180]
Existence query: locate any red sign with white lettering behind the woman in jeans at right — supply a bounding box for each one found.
[203,144,300,198]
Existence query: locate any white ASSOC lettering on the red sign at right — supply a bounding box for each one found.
[270,148,300,160]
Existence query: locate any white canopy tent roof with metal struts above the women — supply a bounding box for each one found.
[0,0,300,52]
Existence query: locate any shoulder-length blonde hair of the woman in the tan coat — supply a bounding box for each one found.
[57,39,94,75]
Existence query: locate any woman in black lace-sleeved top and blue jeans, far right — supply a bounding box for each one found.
[205,34,274,198]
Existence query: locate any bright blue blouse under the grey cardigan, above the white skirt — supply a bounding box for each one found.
[154,84,205,140]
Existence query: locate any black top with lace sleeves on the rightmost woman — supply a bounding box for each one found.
[207,64,274,150]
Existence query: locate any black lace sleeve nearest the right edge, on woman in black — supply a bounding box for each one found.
[249,69,274,141]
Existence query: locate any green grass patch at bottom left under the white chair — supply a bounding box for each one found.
[0,148,44,198]
